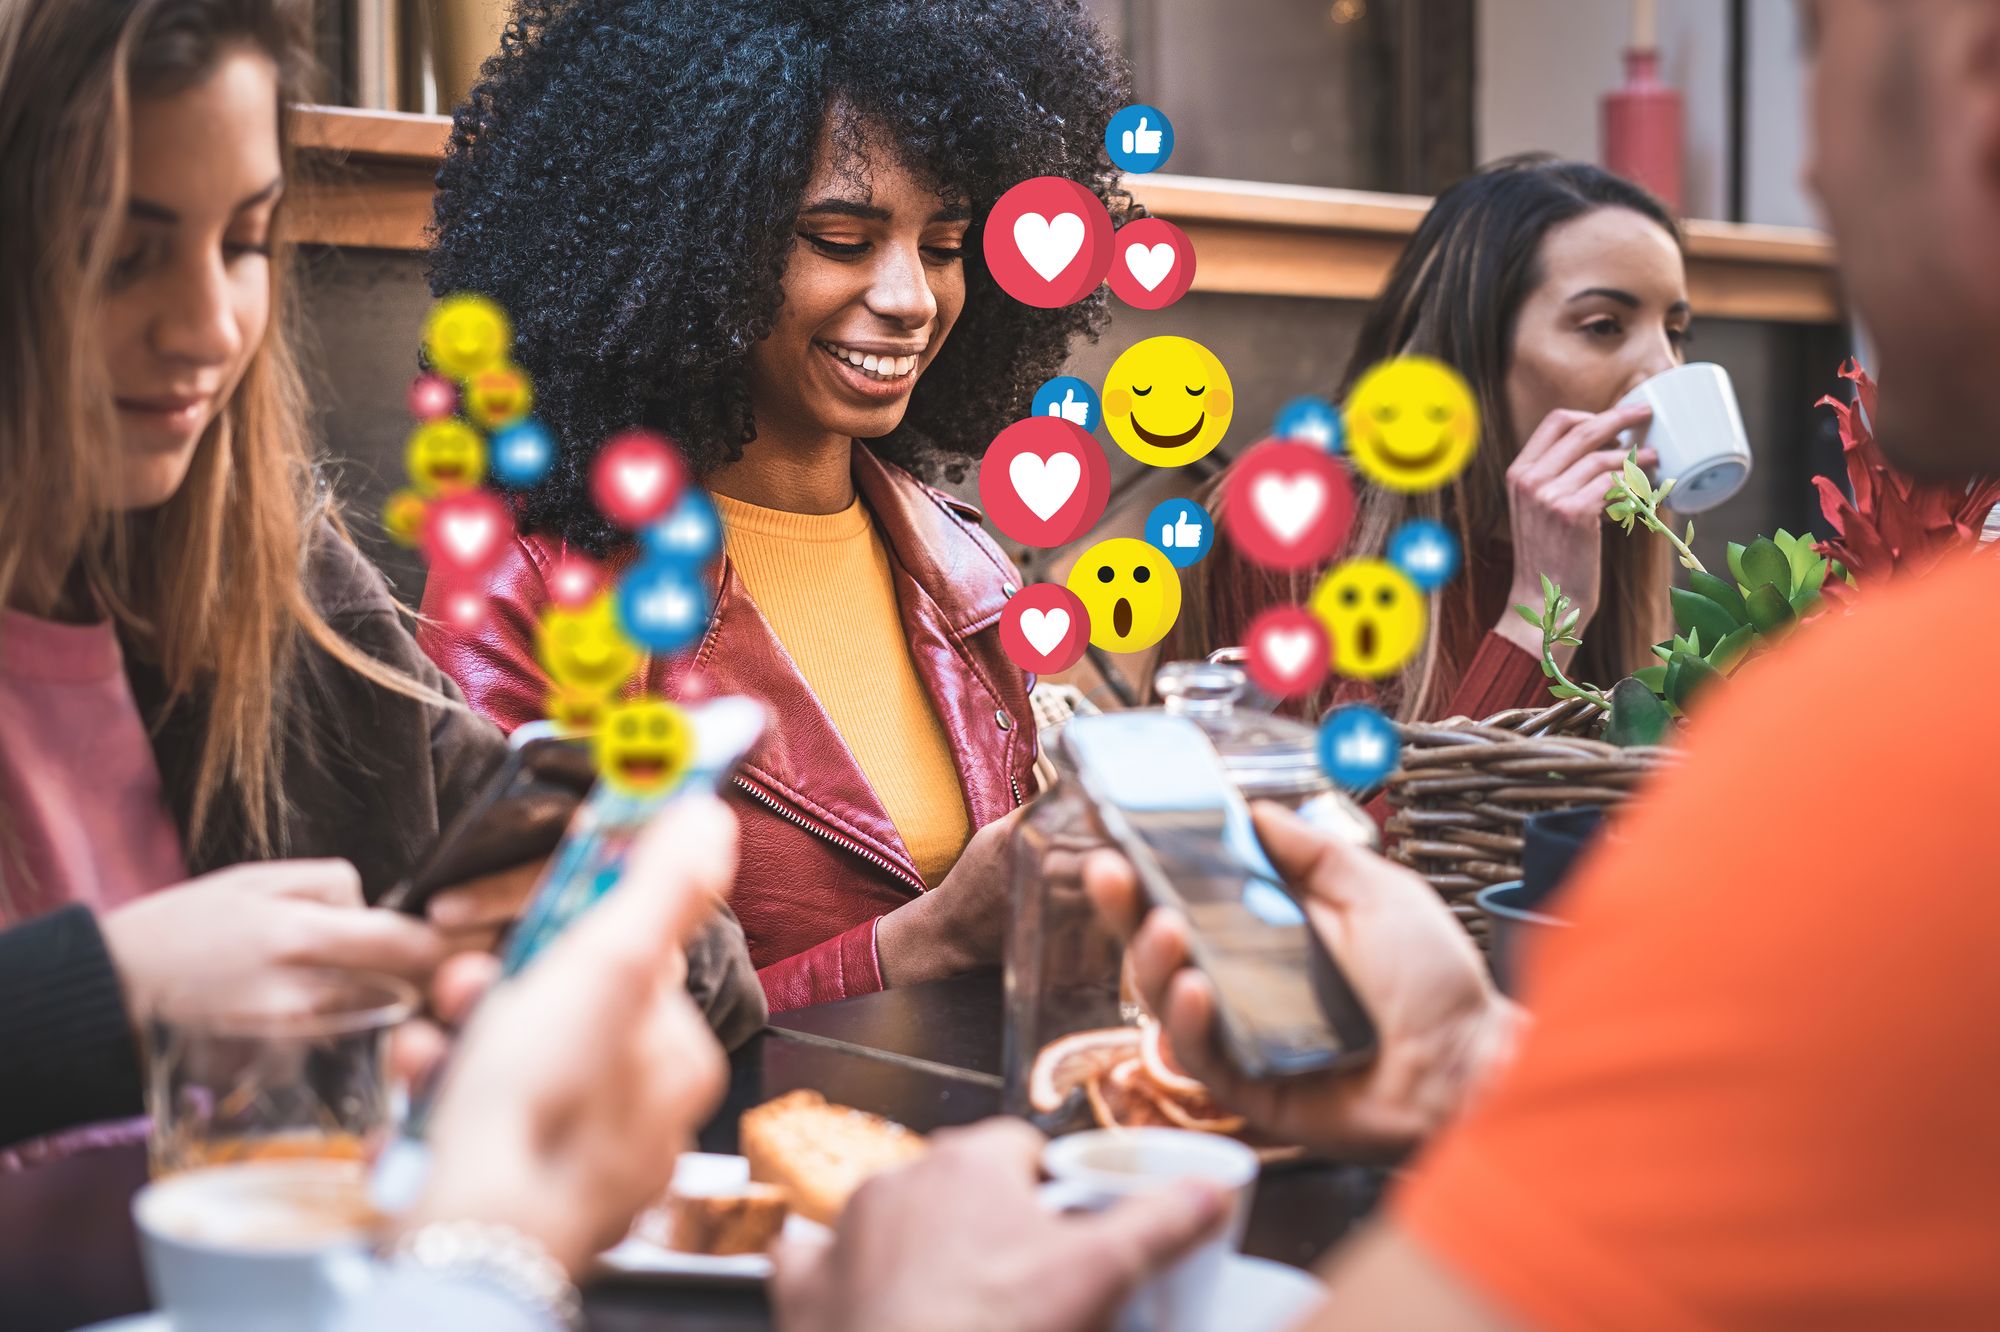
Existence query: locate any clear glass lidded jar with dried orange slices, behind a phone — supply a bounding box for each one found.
[1004,662,1378,1132]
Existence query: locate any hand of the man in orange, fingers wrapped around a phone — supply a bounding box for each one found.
[1084,802,1522,1162]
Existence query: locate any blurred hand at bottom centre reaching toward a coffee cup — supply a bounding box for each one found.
[772,1120,1228,1332]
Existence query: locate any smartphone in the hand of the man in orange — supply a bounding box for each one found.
[1056,712,1376,1078]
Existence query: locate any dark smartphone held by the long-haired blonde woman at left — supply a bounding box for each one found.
[378,722,598,916]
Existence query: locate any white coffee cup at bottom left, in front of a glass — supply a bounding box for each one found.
[132,1160,374,1332]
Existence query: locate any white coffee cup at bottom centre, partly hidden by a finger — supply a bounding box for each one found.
[1042,1128,1258,1332]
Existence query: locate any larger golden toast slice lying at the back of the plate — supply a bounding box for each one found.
[738,1090,924,1226]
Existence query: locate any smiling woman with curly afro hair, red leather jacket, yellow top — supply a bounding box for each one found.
[426,0,1128,1008]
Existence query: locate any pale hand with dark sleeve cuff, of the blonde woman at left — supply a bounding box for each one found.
[100,860,448,1016]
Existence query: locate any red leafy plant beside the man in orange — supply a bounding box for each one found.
[1812,360,2000,602]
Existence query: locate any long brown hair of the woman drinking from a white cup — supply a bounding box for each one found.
[1160,154,1682,720]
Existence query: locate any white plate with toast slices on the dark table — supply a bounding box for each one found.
[598,1092,924,1286]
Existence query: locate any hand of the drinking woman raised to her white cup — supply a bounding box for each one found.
[1494,404,1658,666]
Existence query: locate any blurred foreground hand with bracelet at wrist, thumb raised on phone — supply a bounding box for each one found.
[402,798,736,1274]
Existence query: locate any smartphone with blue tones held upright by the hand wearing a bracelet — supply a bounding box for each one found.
[500,696,766,976]
